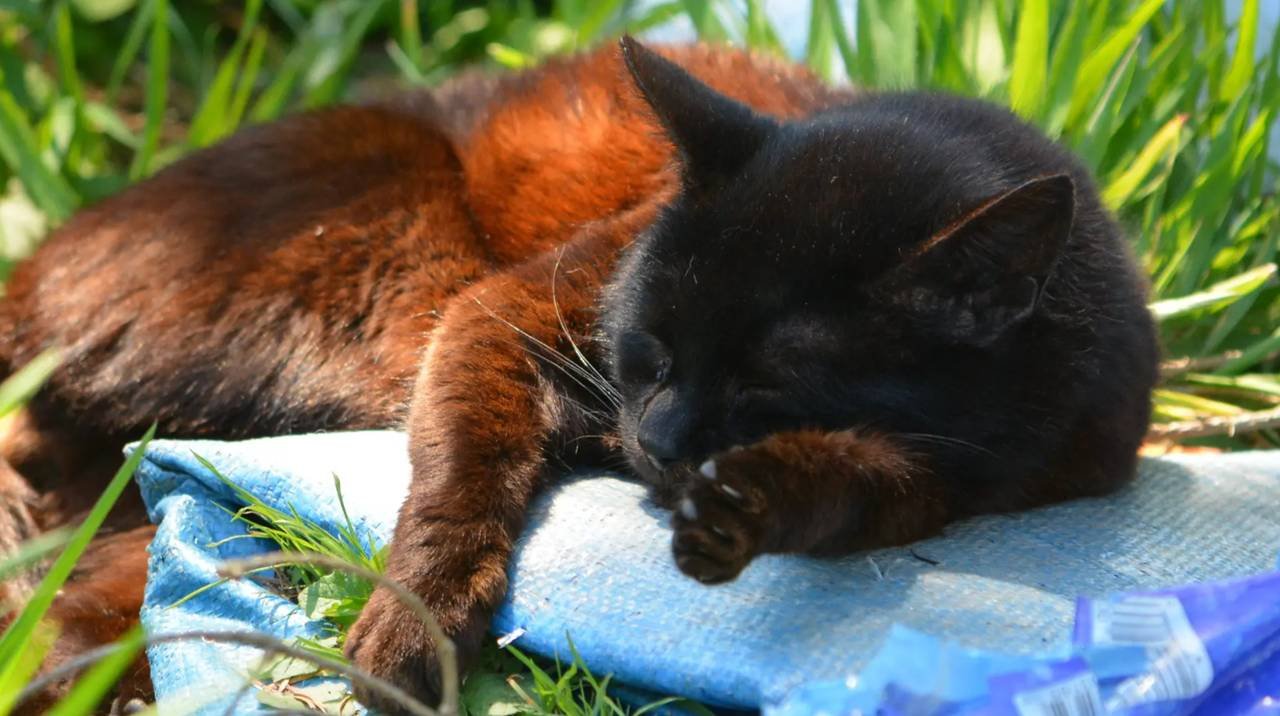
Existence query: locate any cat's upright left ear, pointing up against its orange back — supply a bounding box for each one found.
[620,36,777,188]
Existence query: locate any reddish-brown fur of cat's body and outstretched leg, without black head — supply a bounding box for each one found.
[0,47,855,712]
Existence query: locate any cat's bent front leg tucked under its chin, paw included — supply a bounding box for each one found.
[672,430,951,584]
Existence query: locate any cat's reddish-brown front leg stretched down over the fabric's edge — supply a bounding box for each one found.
[347,209,652,710]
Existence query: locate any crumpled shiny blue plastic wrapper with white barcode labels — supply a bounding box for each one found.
[771,573,1280,716]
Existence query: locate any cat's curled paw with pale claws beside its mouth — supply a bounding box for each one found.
[672,450,767,584]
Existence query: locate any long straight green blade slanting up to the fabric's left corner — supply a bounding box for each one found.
[0,425,156,665]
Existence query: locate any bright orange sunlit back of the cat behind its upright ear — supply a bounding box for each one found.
[434,45,851,257]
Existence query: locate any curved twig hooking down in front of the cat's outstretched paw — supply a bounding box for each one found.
[218,552,458,716]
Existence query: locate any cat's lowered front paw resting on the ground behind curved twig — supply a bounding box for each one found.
[346,588,486,713]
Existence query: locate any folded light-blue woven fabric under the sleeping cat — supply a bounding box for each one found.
[137,432,1280,712]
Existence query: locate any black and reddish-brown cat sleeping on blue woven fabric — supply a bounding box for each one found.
[0,40,1156,706]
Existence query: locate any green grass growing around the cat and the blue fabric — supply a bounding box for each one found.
[0,0,1280,716]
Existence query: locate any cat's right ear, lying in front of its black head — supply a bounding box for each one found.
[906,174,1075,346]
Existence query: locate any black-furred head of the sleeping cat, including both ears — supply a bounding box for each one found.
[605,44,1157,512]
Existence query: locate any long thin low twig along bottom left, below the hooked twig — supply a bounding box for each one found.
[14,631,436,716]
